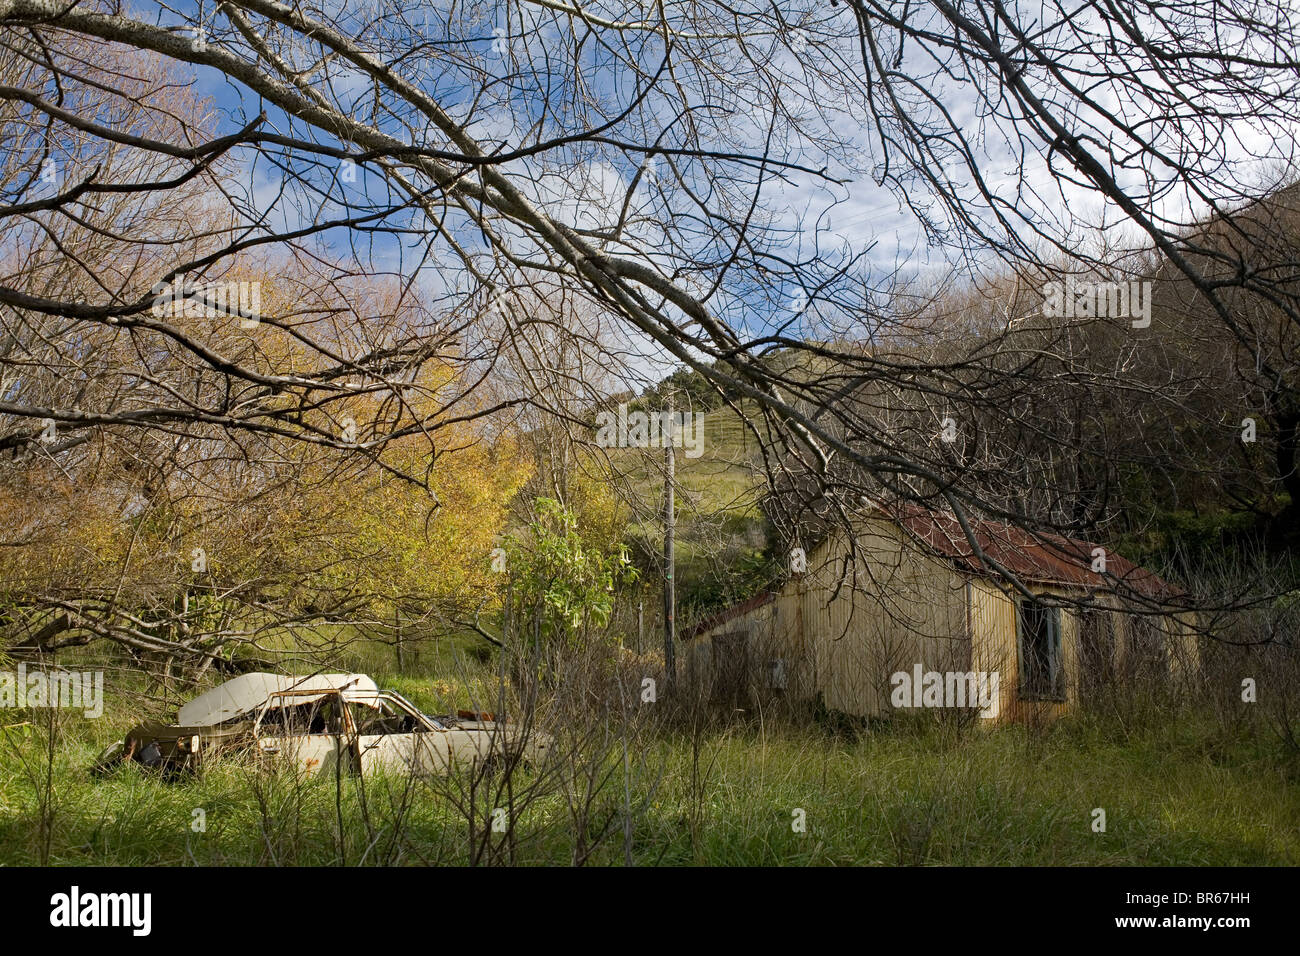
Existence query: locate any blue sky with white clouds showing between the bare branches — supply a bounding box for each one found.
[139,0,1288,382]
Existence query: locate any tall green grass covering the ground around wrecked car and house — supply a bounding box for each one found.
[0,600,1300,865]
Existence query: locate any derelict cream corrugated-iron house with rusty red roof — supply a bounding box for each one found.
[684,505,1199,721]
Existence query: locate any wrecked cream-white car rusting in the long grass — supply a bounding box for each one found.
[95,674,550,775]
